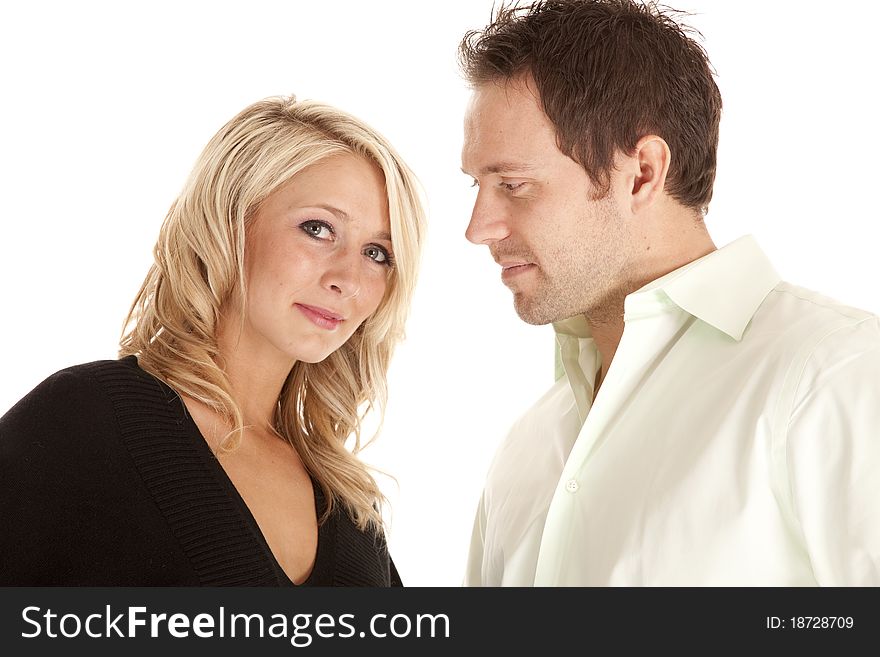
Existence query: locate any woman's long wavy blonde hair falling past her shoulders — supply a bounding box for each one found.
[119,97,425,529]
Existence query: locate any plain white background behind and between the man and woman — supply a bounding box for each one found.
[0,0,880,586]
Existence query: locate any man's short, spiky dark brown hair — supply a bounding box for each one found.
[459,0,721,212]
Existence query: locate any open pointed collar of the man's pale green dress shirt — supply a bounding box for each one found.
[553,235,781,341]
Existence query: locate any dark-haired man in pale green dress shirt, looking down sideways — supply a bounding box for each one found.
[460,0,880,586]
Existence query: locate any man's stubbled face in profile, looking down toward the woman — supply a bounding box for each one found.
[462,81,633,324]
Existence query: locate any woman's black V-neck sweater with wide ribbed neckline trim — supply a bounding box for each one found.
[0,356,400,586]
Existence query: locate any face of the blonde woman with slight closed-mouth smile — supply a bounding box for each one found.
[237,154,393,365]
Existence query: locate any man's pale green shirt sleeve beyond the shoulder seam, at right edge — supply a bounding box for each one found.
[786,318,880,586]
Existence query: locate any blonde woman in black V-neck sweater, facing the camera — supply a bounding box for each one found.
[0,93,424,586]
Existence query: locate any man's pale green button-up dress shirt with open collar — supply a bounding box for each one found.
[465,237,880,586]
